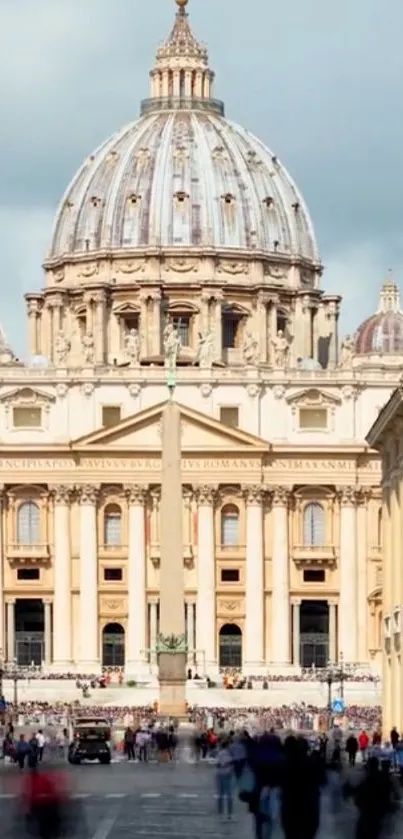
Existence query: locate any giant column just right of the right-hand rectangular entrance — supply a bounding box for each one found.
[339,487,357,663]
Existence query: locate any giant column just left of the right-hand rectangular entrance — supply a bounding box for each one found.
[271,487,291,665]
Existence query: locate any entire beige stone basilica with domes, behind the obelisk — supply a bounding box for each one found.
[0,0,403,677]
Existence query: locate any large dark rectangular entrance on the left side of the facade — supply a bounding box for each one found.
[15,599,45,667]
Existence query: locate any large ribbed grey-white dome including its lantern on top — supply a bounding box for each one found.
[48,0,319,265]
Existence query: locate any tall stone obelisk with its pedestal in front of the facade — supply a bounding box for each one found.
[157,324,187,717]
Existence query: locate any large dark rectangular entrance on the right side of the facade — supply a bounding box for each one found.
[300,600,329,667]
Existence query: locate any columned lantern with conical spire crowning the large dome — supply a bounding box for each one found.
[141,0,224,116]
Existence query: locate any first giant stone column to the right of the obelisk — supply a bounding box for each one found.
[196,486,217,675]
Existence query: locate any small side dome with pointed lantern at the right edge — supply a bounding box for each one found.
[355,277,403,355]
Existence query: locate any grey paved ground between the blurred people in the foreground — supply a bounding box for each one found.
[0,763,402,839]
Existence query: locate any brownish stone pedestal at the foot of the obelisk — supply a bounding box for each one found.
[158,650,187,717]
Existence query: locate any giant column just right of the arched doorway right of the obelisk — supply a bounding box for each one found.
[243,486,264,674]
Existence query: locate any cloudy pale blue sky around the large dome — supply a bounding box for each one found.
[0,0,403,354]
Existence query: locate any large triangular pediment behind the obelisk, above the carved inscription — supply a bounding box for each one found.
[72,402,270,453]
